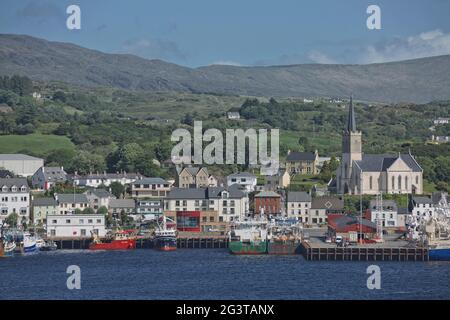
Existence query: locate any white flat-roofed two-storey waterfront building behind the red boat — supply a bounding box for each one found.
[47,213,106,238]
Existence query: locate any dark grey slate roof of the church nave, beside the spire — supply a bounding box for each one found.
[355,154,422,172]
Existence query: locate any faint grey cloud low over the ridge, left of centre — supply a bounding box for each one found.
[120,39,187,61]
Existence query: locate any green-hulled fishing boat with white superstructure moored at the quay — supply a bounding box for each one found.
[228,218,268,255]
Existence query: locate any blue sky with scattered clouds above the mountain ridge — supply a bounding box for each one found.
[0,0,450,67]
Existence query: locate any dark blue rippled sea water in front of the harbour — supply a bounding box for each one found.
[0,249,450,299]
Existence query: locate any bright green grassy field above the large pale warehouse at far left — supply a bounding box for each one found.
[0,133,74,154]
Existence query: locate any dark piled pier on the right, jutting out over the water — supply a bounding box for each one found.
[300,242,429,261]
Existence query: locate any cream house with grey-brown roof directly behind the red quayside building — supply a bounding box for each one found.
[308,197,344,225]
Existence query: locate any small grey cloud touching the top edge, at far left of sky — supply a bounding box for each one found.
[16,1,65,22]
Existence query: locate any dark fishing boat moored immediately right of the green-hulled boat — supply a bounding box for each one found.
[267,219,302,255]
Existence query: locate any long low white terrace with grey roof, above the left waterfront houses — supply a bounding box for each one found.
[71,172,144,188]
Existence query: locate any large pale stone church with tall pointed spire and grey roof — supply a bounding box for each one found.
[336,98,423,195]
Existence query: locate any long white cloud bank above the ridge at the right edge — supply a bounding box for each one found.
[358,29,450,63]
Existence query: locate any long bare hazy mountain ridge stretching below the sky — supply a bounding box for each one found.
[0,34,450,103]
